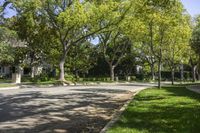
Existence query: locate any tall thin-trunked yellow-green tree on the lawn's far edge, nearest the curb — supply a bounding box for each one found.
[143,0,186,88]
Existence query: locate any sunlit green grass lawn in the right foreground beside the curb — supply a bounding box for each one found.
[108,86,200,133]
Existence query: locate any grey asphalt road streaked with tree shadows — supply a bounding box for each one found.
[0,84,153,133]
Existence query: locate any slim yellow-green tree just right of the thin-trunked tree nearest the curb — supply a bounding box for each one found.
[163,15,191,85]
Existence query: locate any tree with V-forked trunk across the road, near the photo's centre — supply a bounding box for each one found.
[97,0,149,81]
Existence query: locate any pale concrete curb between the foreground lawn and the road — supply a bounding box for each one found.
[100,88,147,133]
